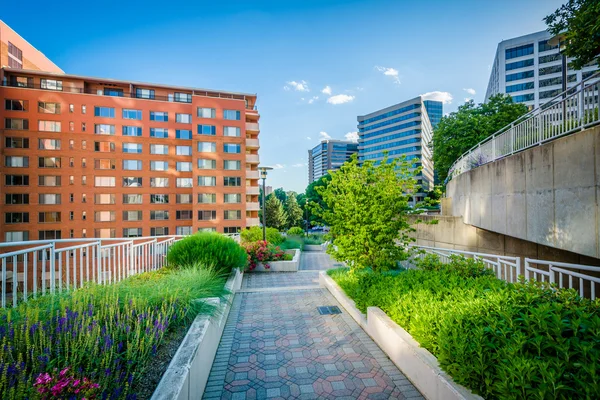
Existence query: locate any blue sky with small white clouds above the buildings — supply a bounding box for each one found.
[0,0,562,192]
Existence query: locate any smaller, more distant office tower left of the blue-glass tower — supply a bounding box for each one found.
[308,139,358,183]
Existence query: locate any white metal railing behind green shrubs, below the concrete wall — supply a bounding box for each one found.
[404,246,600,300]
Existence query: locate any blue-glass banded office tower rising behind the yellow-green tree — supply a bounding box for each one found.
[358,96,443,202]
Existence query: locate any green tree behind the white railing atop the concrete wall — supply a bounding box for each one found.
[431,94,528,181]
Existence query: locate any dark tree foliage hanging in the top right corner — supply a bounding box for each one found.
[544,0,600,69]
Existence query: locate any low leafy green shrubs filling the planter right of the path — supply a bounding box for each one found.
[328,258,600,399]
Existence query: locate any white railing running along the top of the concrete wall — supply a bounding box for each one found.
[448,72,600,179]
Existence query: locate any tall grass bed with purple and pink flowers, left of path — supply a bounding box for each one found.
[0,268,225,399]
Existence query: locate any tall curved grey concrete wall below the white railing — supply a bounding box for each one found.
[442,127,600,258]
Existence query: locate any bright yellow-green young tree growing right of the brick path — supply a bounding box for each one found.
[315,155,419,271]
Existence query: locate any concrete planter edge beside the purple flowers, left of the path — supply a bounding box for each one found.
[151,270,244,400]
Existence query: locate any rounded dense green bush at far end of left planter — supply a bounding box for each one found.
[167,232,248,274]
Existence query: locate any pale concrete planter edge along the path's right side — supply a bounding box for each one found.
[319,271,482,400]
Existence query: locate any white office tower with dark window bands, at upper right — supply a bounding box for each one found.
[485,31,598,108]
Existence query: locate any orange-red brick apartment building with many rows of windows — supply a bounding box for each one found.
[0,21,259,241]
